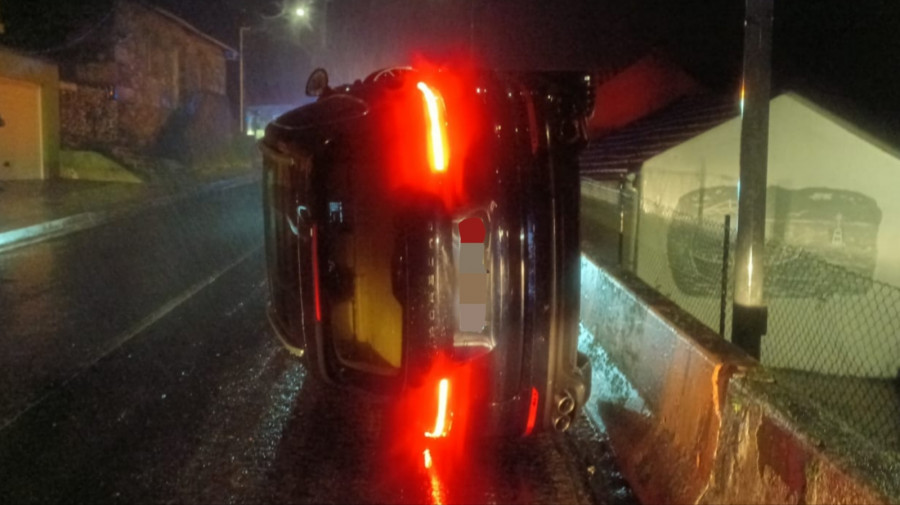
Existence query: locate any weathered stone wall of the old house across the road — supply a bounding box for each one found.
[62,1,232,162]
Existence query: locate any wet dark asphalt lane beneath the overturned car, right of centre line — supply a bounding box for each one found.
[0,188,634,504]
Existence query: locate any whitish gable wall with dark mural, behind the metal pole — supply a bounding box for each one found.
[636,93,900,379]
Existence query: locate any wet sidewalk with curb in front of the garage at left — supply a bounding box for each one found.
[0,170,260,252]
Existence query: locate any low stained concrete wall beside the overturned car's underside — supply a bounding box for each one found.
[581,258,900,504]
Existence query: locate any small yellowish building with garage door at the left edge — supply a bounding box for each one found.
[0,47,59,180]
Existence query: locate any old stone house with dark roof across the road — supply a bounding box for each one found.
[2,0,237,178]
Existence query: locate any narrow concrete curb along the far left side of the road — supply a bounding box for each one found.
[0,174,260,252]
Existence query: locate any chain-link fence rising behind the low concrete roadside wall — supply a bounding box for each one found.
[583,179,900,451]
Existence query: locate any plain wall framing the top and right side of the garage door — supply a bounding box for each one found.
[0,47,60,178]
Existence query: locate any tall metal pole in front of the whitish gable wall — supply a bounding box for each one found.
[731,0,773,359]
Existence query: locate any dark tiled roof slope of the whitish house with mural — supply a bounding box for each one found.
[579,93,739,179]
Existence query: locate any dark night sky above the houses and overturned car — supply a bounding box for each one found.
[0,0,900,140]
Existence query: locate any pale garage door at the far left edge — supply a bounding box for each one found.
[0,77,43,180]
